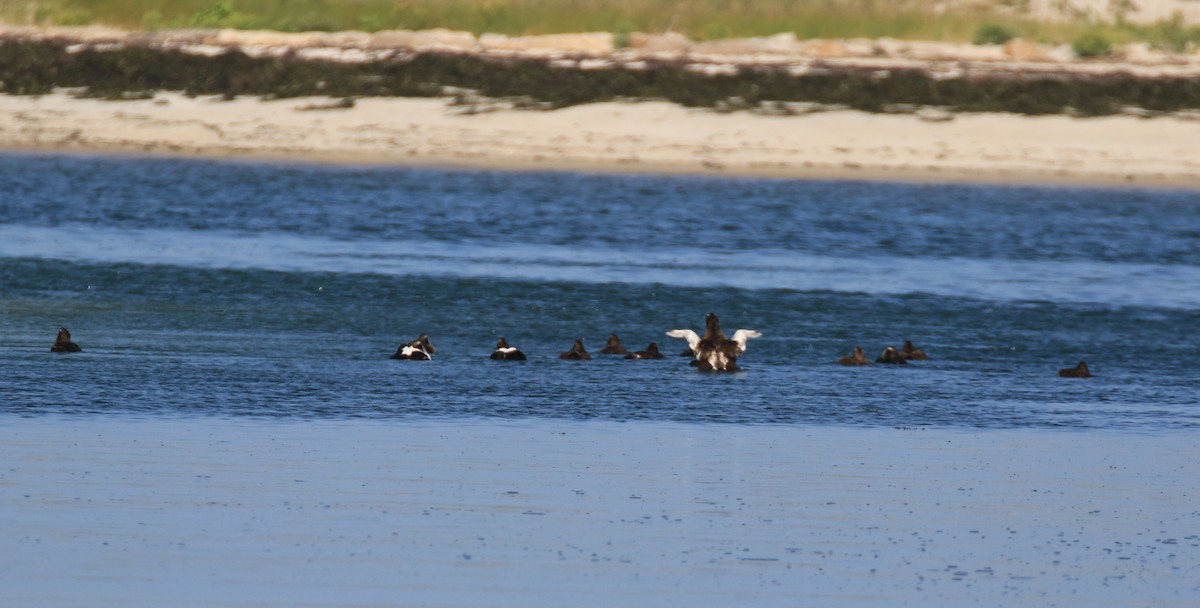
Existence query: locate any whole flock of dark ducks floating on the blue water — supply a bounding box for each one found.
[50,313,1092,378]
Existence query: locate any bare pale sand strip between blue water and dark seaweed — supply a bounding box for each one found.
[0,92,1200,188]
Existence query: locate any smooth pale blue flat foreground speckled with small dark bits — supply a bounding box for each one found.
[0,416,1200,607]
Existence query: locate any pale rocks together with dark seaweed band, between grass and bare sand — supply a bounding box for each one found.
[0,28,1200,119]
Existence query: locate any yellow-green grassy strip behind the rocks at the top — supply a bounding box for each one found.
[0,0,1200,47]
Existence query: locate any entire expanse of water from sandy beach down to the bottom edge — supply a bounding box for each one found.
[0,155,1200,606]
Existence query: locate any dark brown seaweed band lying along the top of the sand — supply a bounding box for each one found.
[0,38,1200,116]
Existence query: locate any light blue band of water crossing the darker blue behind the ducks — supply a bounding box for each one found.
[0,224,1200,309]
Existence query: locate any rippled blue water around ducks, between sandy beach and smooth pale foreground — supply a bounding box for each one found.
[0,155,1200,431]
